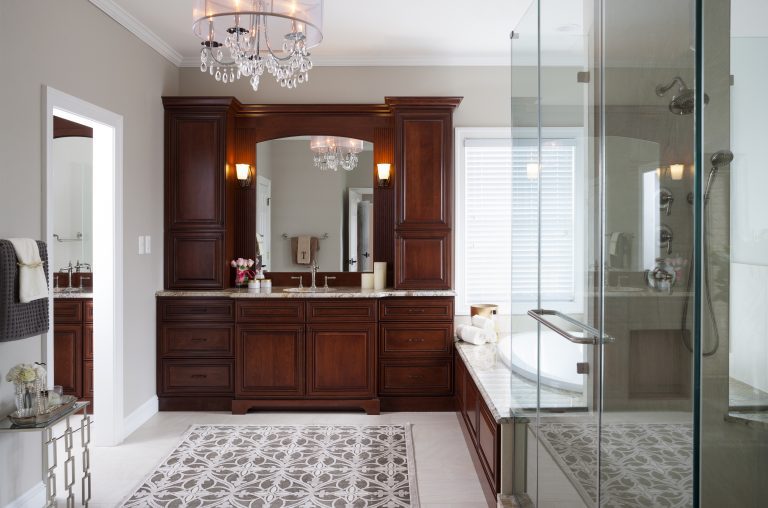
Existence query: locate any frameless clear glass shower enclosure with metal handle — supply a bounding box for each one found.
[510,0,768,507]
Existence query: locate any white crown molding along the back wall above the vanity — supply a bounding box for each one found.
[179,56,509,67]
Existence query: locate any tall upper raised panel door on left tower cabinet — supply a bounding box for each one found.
[165,112,226,229]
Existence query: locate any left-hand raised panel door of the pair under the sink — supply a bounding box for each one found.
[235,325,304,397]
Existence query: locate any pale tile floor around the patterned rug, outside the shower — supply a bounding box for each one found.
[57,412,487,508]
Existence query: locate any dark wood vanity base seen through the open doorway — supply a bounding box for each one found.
[53,298,93,411]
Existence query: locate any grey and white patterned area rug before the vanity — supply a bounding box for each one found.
[123,425,419,508]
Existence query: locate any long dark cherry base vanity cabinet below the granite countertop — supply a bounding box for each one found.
[157,297,454,414]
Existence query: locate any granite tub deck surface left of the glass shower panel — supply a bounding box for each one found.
[456,341,515,423]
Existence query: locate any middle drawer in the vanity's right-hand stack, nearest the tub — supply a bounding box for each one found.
[379,323,453,356]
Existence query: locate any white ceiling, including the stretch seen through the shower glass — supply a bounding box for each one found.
[90,0,768,68]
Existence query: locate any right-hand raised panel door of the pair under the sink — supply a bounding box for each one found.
[307,323,376,399]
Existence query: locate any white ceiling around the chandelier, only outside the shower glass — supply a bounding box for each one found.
[90,0,533,67]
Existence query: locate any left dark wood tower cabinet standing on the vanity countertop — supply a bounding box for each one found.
[163,97,234,289]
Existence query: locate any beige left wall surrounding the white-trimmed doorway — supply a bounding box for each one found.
[0,0,178,506]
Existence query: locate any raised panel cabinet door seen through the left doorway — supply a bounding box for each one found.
[53,324,83,398]
